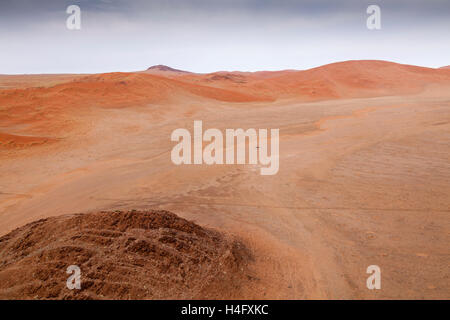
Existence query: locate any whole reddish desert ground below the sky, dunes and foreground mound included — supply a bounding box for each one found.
[0,61,450,299]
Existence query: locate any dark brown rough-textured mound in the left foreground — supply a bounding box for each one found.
[0,210,251,299]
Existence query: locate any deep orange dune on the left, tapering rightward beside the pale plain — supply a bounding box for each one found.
[0,73,265,133]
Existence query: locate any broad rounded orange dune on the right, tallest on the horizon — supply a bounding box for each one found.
[243,61,450,100]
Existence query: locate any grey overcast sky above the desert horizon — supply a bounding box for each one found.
[0,0,450,74]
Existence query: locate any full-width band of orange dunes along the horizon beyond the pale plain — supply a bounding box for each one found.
[0,60,450,148]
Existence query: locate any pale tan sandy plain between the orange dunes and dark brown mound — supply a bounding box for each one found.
[0,87,450,299]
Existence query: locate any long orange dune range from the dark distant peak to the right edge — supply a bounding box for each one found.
[170,60,450,101]
